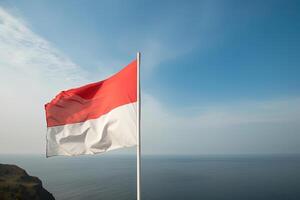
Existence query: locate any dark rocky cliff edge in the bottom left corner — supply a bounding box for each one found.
[0,164,54,200]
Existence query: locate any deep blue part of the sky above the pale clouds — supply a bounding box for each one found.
[4,1,300,106]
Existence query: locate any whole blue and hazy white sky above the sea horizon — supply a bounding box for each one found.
[0,0,300,155]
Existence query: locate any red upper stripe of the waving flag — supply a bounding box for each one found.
[45,60,137,127]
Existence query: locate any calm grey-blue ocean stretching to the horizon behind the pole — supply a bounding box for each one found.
[0,154,300,200]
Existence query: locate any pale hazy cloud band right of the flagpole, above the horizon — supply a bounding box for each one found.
[142,95,300,154]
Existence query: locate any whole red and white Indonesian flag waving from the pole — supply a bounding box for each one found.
[45,60,137,157]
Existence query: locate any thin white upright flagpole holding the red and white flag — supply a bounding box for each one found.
[136,52,141,200]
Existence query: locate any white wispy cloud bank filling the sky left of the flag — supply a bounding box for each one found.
[0,7,86,153]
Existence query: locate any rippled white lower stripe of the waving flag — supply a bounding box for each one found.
[47,102,137,156]
